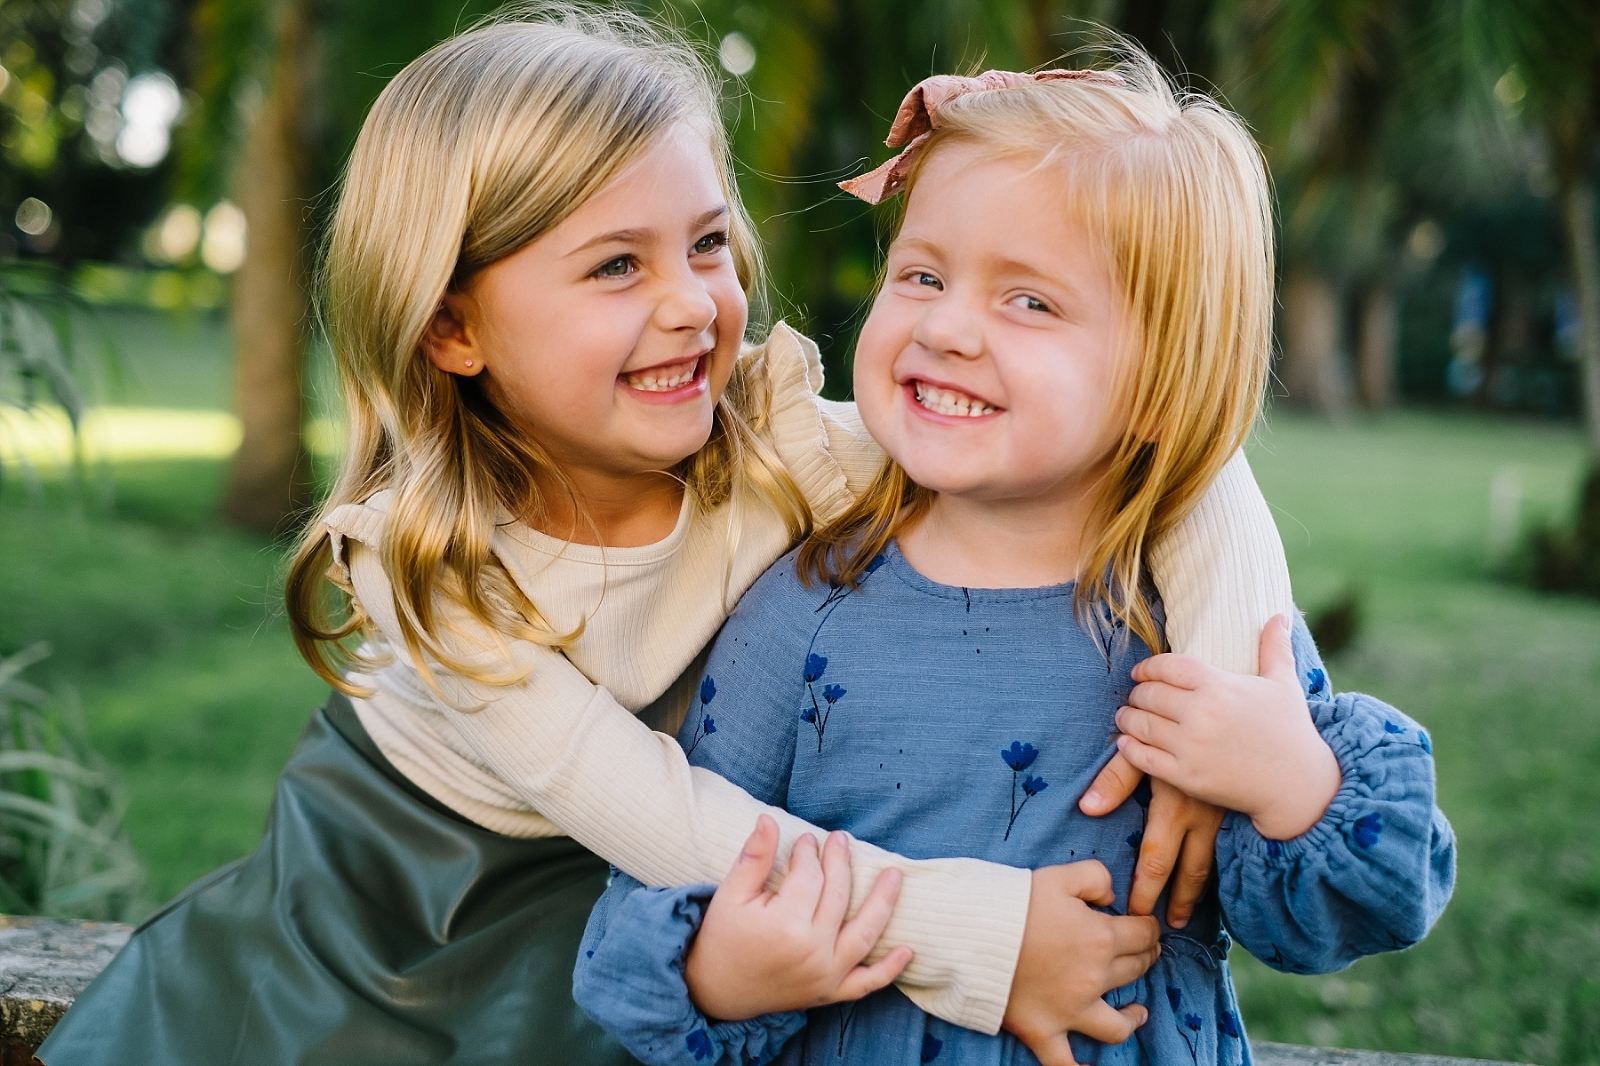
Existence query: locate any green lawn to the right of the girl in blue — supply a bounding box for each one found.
[1234,415,1600,1063]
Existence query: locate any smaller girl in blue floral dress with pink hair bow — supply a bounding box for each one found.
[576,58,1454,1066]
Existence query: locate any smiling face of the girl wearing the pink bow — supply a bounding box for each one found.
[854,142,1128,515]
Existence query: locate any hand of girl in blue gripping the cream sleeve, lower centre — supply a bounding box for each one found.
[683,815,910,1021]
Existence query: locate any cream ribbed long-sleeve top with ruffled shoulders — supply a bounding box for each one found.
[326,325,1290,1032]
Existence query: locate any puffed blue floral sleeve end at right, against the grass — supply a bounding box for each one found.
[1218,688,1454,973]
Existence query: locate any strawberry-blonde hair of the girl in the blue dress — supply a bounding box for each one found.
[800,48,1274,650]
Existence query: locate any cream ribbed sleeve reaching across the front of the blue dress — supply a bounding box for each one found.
[341,541,1032,1032]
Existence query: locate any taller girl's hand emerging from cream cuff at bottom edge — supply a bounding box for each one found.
[1005,860,1162,1066]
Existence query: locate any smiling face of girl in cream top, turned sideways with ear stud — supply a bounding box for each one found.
[427,123,749,483]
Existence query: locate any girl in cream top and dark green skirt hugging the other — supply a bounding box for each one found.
[40,13,1288,1066]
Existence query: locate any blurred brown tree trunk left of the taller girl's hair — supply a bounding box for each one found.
[226,0,310,530]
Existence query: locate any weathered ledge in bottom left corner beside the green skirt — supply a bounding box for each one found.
[0,914,133,1066]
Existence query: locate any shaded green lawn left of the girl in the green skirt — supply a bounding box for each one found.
[0,463,326,917]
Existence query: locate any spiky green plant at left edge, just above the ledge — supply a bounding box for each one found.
[0,643,142,919]
